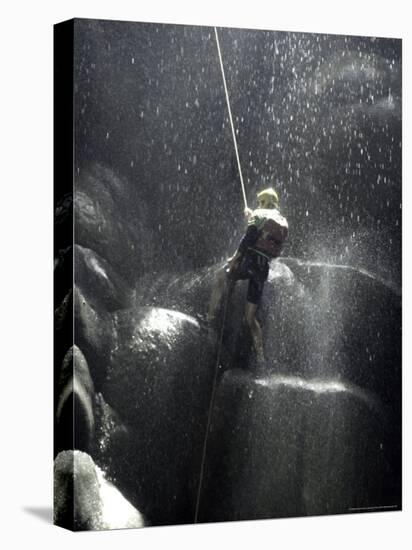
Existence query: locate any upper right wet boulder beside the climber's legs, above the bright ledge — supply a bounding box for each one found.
[260,259,401,411]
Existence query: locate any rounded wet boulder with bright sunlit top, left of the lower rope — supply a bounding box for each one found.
[102,308,214,525]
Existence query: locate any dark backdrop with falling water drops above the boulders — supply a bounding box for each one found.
[75,20,401,285]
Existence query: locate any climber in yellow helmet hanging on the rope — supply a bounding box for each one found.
[208,187,288,366]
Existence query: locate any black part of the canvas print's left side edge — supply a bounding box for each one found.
[53,19,75,530]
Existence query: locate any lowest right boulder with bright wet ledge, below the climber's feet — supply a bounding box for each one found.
[199,370,399,521]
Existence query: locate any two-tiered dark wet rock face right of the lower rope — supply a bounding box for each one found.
[186,259,401,521]
